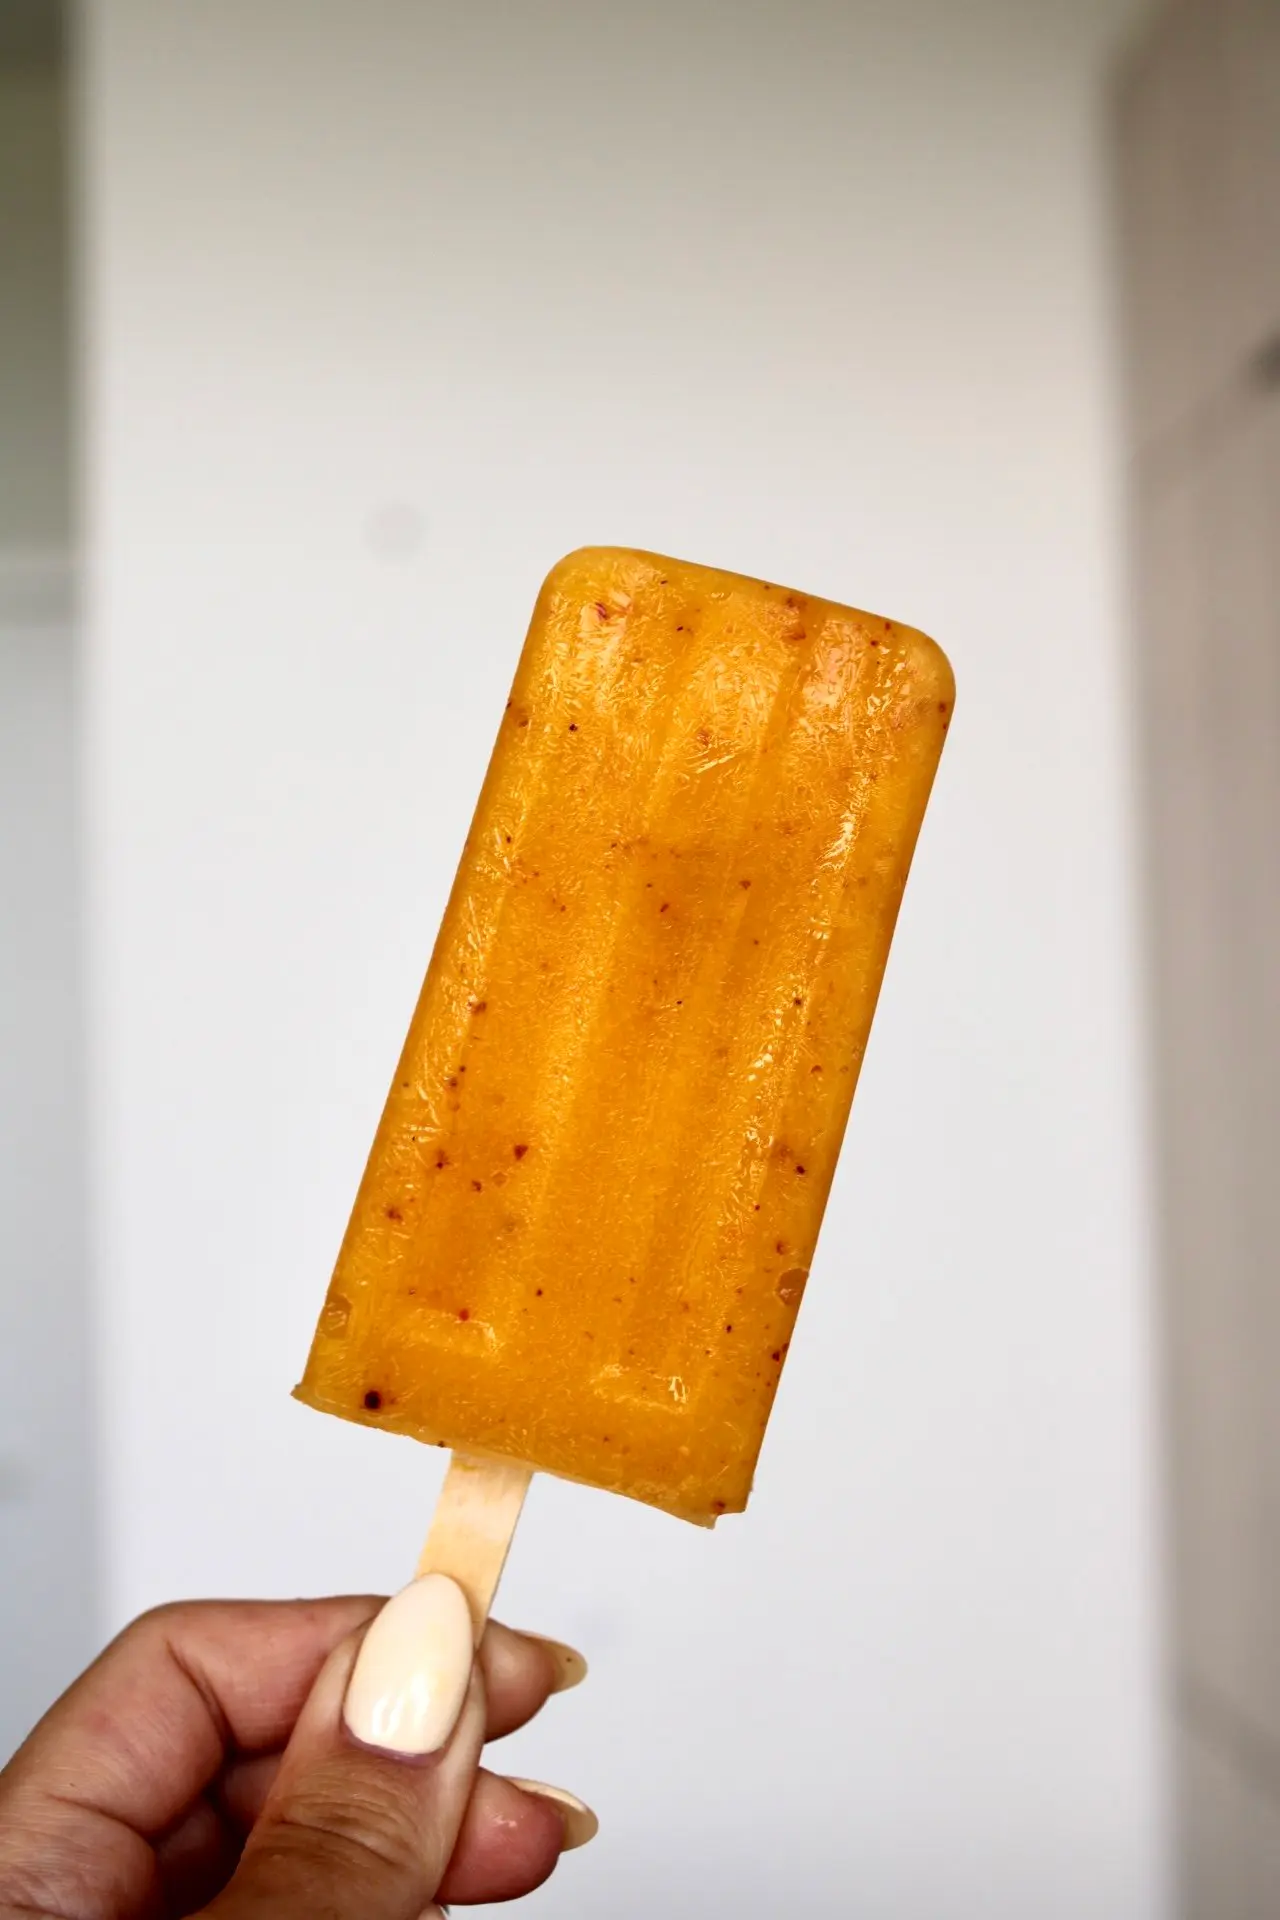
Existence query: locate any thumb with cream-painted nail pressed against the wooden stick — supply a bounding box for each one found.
[205,1574,484,1920]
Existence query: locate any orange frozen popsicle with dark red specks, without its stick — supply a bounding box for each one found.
[296,549,954,1597]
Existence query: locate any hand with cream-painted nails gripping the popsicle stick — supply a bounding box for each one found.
[0,1582,595,1920]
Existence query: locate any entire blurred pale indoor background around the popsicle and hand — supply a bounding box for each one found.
[0,0,1280,1920]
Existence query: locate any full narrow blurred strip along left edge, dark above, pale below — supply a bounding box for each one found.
[0,26,98,1763]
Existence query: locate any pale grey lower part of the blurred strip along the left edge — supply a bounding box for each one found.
[0,579,100,1764]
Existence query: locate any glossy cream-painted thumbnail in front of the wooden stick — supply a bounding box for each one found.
[342,1572,472,1757]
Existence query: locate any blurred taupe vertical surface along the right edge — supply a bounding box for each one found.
[1117,0,1280,1920]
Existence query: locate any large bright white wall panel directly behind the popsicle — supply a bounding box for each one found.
[77,0,1159,1920]
